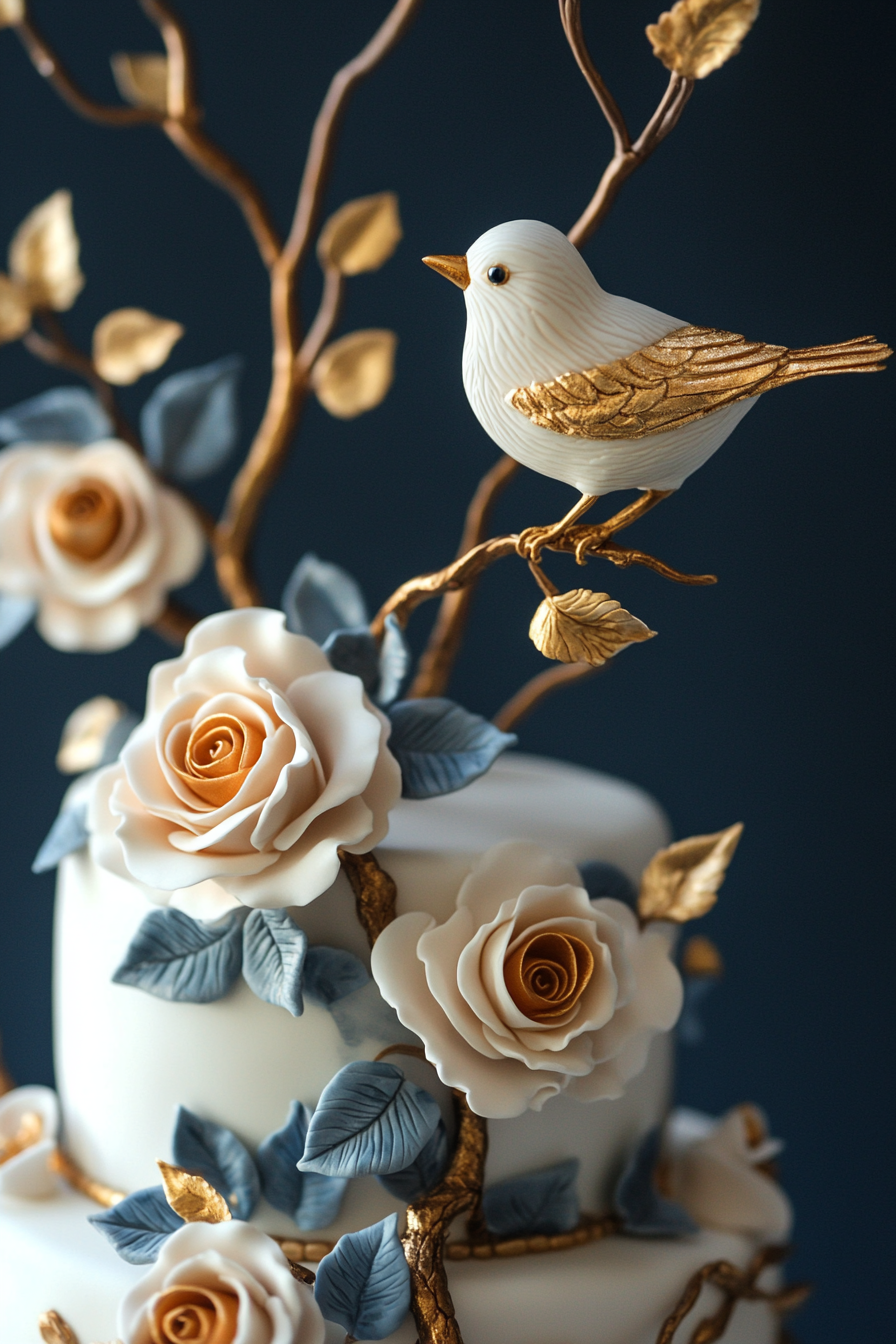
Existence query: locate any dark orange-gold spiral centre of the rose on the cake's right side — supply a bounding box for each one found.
[504,933,594,1021]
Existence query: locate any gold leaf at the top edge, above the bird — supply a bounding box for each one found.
[647,0,759,79]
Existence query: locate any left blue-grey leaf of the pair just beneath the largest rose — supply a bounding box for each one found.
[111,907,243,1004]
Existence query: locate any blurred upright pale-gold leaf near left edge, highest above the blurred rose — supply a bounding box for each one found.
[9,191,85,312]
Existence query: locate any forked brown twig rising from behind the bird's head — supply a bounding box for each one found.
[560,0,695,247]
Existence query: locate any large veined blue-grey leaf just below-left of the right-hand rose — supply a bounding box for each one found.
[300,1059,441,1176]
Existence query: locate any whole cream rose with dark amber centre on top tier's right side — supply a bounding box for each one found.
[372,841,681,1120]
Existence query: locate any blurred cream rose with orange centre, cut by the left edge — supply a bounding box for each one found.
[0,439,206,650]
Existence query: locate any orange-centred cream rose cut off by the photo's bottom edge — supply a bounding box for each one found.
[118,1222,326,1344]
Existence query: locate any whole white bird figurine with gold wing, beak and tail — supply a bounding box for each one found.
[423,219,892,559]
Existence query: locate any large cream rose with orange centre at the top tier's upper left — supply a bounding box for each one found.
[89,607,402,918]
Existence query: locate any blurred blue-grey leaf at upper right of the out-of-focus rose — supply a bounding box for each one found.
[140,355,243,481]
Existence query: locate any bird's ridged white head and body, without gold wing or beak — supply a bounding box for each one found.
[463,219,755,495]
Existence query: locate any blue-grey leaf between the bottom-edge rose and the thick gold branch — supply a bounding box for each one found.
[314,1214,411,1340]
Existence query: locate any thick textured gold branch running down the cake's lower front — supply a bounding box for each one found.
[402,1093,488,1344]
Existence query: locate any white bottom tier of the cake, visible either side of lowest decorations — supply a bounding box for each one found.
[0,1191,778,1344]
